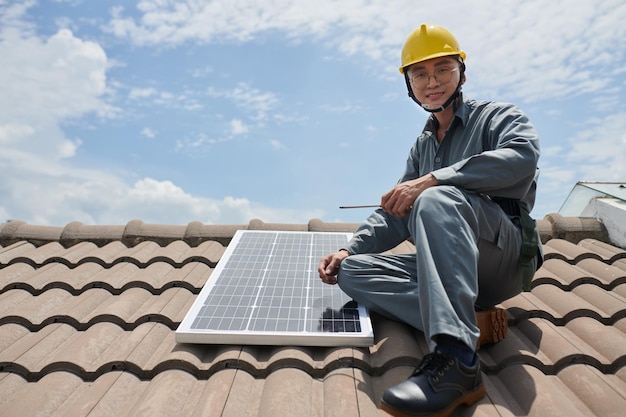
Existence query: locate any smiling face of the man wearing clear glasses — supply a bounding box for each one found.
[406,56,465,109]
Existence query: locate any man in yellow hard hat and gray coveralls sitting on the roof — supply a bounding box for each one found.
[318,25,542,416]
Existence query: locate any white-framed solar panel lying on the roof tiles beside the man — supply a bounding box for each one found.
[176,230,373,346]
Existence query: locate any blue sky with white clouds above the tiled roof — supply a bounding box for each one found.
[0,0,626,226]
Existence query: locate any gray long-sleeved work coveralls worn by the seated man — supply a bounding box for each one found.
[337,98,540,350]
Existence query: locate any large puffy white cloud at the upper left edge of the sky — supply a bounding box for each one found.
[0,10,111,161]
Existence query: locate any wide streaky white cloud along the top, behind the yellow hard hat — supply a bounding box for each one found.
[108,0,626,105]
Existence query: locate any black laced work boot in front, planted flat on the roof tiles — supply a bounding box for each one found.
[381,352,485,417]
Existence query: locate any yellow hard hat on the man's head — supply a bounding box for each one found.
[400,25,465,74]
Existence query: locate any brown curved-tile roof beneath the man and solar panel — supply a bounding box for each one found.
[0,215,626,417]
